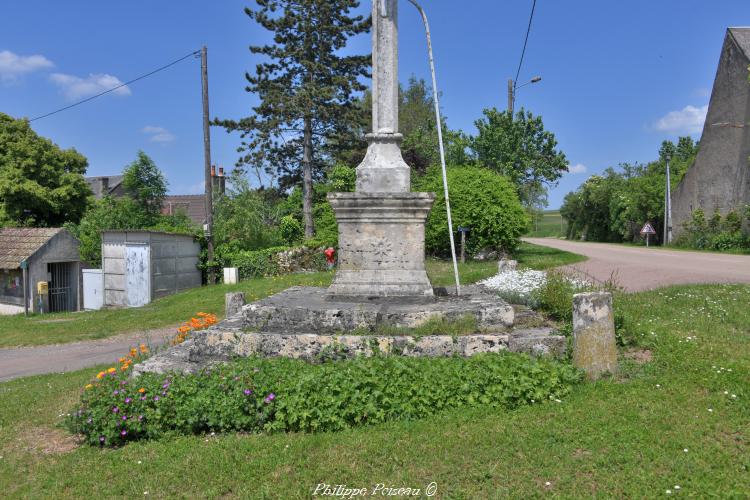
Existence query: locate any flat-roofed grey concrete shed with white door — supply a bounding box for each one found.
[102,231,202,307]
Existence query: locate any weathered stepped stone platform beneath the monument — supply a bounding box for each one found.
[134,286,566,375]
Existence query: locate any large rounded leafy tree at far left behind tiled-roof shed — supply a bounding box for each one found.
[0,113,91,227]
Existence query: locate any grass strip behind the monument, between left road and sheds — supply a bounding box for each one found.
[0,254,528,348]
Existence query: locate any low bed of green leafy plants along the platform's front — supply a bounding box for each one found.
[66,353,581,446]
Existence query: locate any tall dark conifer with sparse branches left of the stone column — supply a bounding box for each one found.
[215,0,371,237]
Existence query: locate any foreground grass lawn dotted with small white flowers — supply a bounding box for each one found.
[0,285,750,499]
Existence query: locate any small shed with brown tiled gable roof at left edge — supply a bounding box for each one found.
[0,227,81,313]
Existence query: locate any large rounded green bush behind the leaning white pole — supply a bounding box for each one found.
[412,167,529,255]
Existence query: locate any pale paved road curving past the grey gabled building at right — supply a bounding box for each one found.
[524,238,750,291]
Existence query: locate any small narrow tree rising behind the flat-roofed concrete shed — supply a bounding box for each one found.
[122,151,167,215]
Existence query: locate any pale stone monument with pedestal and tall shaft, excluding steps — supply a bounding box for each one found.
[328,0,435,297]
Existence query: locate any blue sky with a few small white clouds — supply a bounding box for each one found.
[0,0,750,208]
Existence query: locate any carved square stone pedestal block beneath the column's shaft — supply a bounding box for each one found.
[328,193,435,297]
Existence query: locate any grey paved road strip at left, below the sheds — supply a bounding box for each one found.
[0,328,175,382]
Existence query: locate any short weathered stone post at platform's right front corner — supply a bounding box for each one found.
[573,292,617,380]
